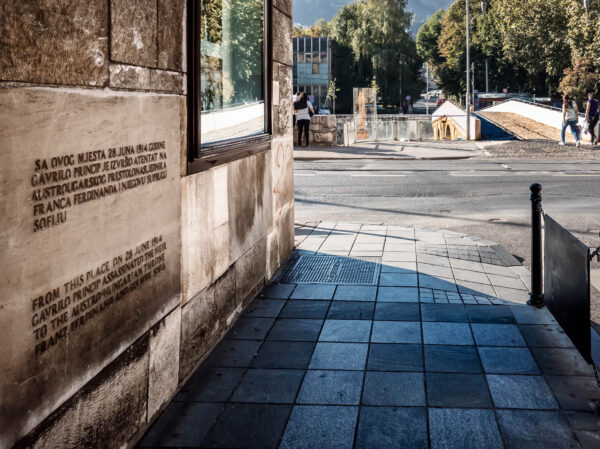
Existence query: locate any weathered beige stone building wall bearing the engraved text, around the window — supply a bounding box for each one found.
[0,0,294,448]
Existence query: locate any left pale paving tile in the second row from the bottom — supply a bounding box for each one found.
[296,370,363,405]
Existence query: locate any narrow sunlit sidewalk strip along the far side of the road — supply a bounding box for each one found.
[294,140,485,161]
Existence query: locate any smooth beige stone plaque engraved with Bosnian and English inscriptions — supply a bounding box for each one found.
[0,88,180,440]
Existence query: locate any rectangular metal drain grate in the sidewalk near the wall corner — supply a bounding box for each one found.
[280,256,381,285]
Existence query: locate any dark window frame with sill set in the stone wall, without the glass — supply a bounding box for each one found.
[187,0,273,175]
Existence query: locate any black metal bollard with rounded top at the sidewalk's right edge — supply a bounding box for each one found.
[527,183,544,307]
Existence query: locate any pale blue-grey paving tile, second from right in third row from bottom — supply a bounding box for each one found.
[478,347,540,374]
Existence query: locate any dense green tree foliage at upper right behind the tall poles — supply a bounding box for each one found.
[417,0,600,95]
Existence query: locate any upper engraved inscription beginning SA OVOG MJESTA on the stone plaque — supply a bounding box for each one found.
[31,141,168,232]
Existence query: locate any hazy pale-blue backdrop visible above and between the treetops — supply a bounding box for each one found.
[293,0,453,34]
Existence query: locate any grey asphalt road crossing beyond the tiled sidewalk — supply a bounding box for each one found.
[295,159,600,268]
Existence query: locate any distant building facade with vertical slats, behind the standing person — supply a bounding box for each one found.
[292,37,333,112]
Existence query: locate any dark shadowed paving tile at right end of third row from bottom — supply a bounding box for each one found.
[531,348,594,376]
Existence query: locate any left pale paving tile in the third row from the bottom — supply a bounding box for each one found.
[309,343,369,370]
